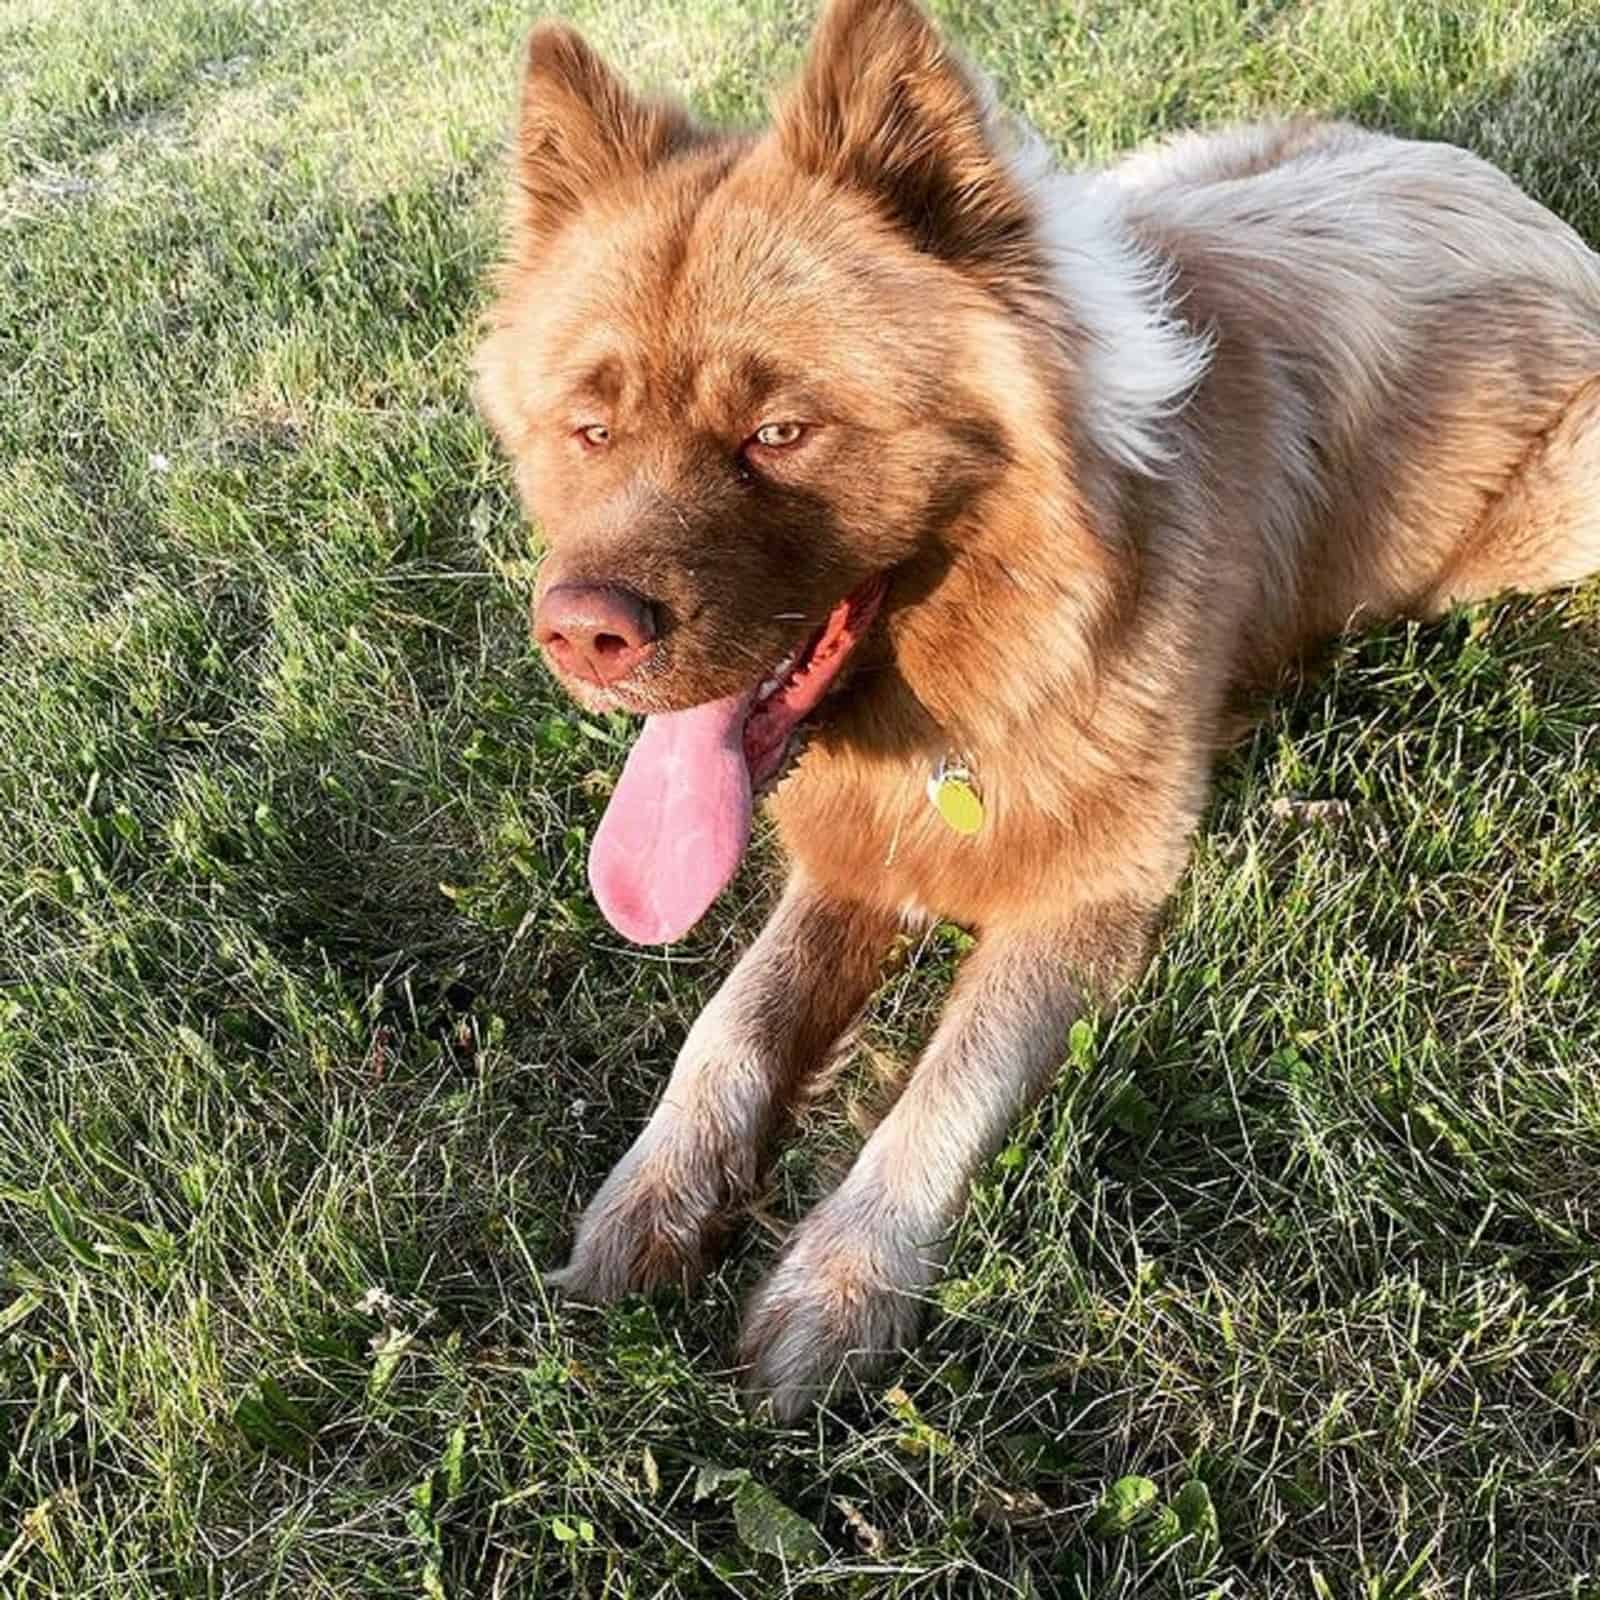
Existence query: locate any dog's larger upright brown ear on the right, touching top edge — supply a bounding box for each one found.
[776,0,1029,261]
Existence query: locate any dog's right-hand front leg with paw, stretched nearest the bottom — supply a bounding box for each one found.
[742,907,1154,1418]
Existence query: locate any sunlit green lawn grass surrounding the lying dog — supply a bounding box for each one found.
[0,0,1600,1600]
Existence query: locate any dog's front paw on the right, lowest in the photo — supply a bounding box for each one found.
[739,1218,938,1422]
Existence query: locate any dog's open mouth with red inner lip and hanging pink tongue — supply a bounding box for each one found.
[589,576,886,944]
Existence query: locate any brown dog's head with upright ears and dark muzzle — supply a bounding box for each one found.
[477,0,1068,931]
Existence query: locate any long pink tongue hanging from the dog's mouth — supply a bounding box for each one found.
[589,694,752,944]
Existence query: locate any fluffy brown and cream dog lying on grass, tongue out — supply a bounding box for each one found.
[475,0,1600,1418]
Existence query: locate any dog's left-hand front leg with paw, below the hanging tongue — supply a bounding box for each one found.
[549,874,896,1301]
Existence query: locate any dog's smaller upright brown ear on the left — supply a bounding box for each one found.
[512,22,698,245]
